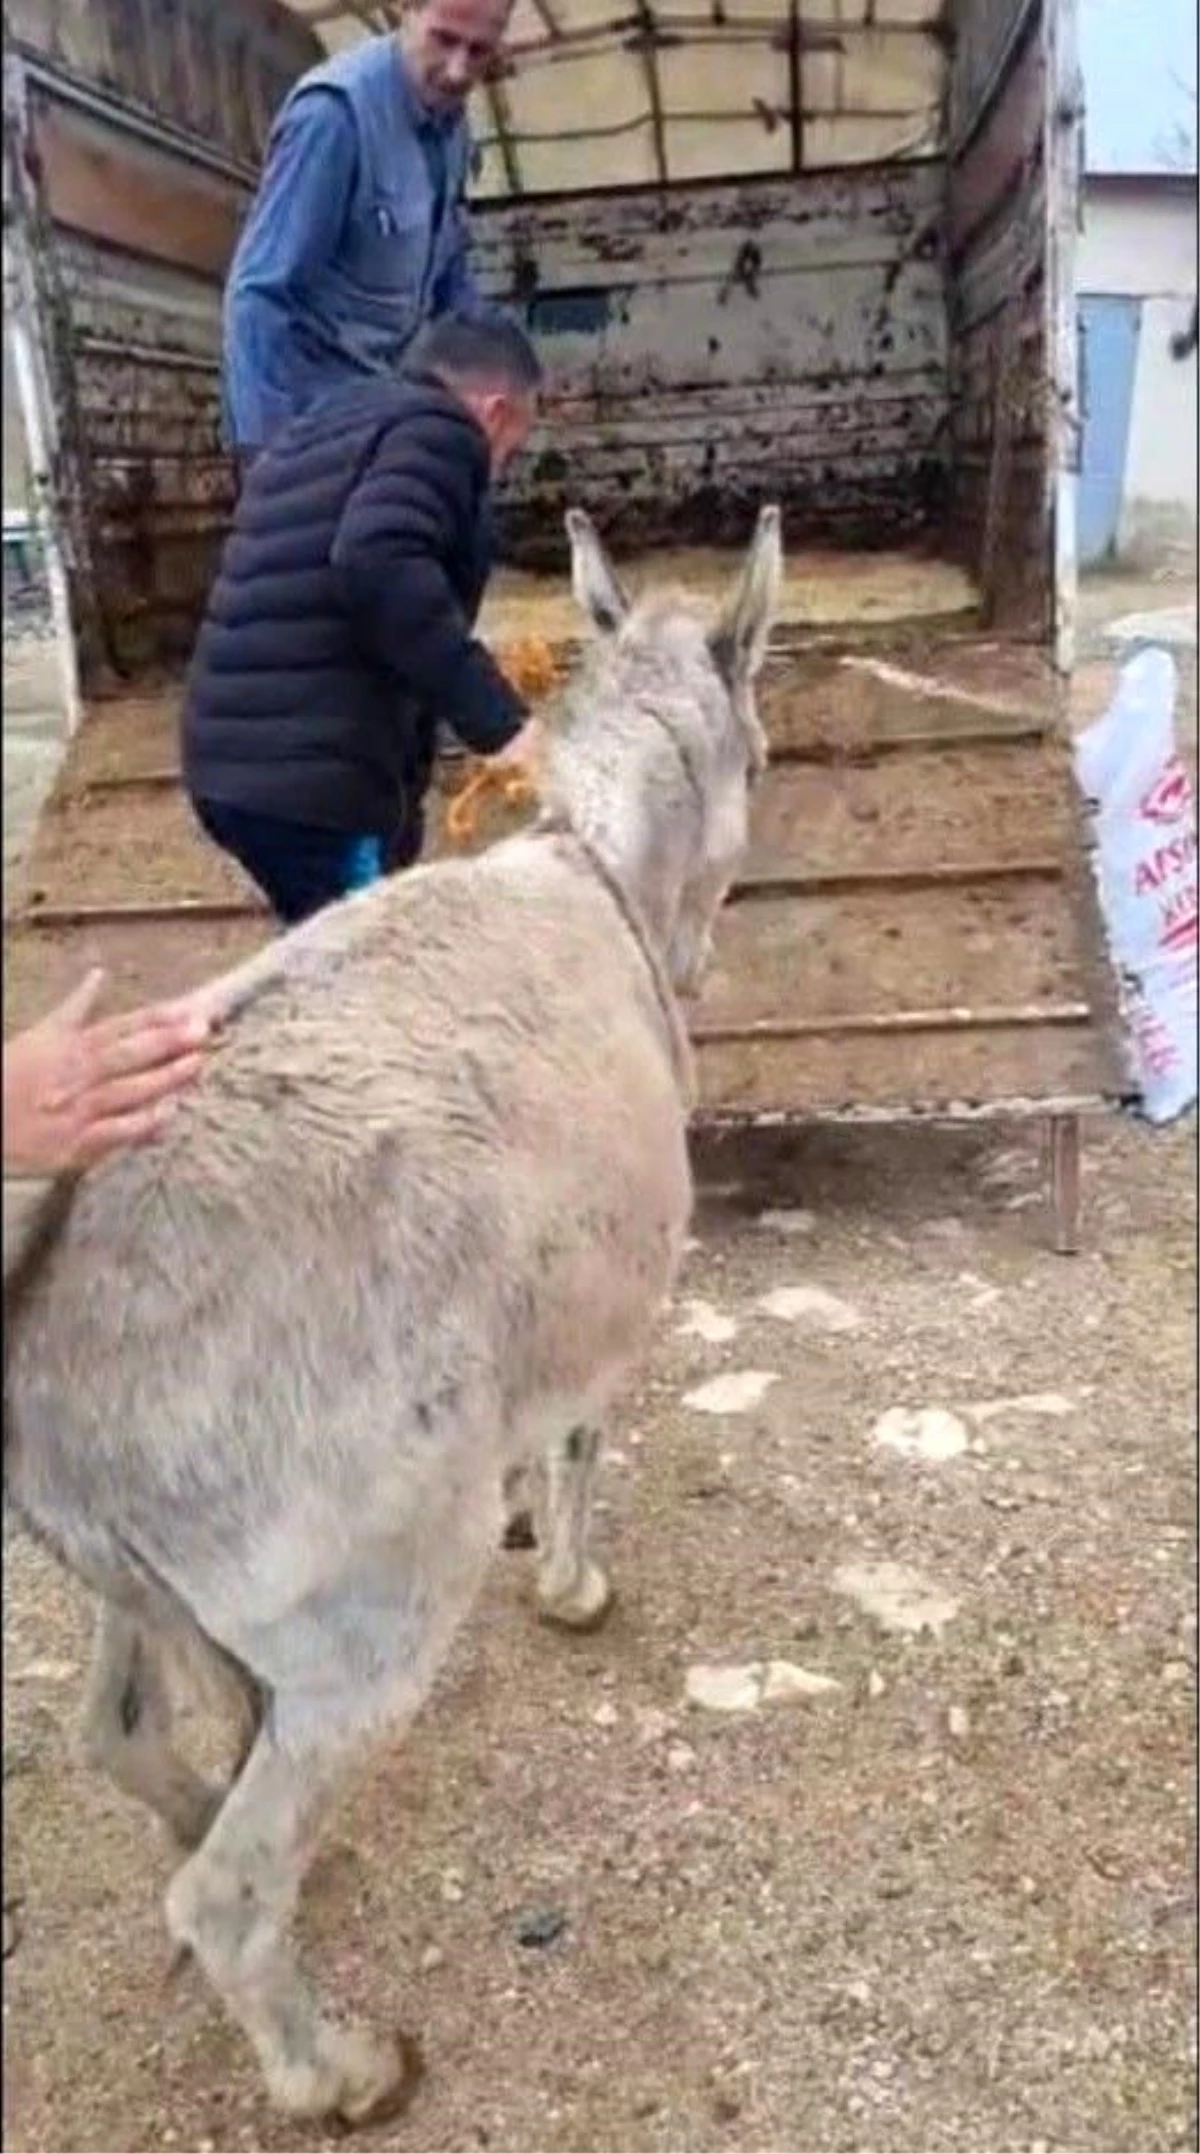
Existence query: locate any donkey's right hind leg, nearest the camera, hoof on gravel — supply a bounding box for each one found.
[166,1490,500,2124]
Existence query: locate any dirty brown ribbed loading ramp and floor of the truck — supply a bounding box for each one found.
[4,554,1122,1122]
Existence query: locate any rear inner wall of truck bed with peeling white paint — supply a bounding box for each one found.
[476,164,948,567]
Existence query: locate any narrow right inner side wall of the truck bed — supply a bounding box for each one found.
[948,0,1054,631]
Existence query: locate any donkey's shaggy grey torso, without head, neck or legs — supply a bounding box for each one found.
[6,838,689,1652]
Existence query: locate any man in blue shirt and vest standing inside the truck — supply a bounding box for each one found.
[224,0,511,459]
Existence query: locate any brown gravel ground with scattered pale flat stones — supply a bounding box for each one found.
[4,564,1196,2154]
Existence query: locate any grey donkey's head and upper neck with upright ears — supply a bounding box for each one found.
[549,508,782,993]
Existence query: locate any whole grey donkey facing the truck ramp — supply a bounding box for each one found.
[4,508,782,2124]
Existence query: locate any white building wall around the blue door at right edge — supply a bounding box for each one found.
[1077,177,1198,558]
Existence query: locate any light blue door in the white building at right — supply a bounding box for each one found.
[1077,295,1142,569]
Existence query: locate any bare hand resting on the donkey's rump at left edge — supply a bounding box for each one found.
[4,971,213,1174]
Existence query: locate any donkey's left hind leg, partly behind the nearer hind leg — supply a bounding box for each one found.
[84,1603,224,1848]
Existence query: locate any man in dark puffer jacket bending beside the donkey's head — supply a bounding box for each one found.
[183,317,541,924]
